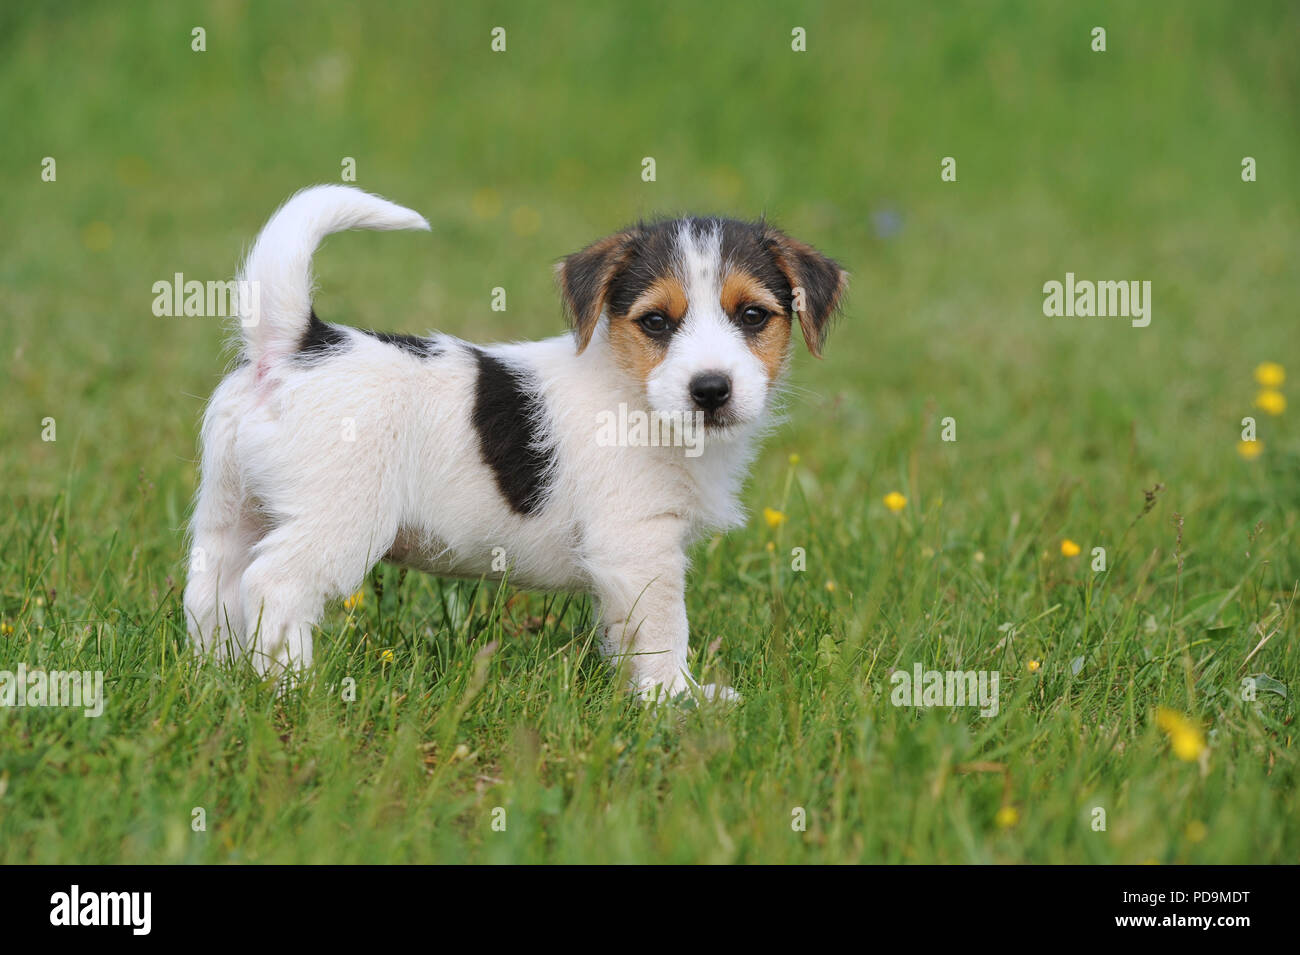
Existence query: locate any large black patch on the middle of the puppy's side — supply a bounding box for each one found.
[475,348,555,515]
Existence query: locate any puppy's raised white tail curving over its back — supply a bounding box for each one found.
[237,186,429,366]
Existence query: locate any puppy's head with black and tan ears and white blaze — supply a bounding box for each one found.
[559,218,846,430]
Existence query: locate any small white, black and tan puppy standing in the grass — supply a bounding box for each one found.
[185,186,846,699]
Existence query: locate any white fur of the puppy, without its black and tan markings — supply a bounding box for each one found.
[185,186,790,698]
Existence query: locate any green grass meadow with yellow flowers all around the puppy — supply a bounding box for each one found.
[0,0,1300,863]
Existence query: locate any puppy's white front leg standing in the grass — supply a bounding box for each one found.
[588,518,737,702]
